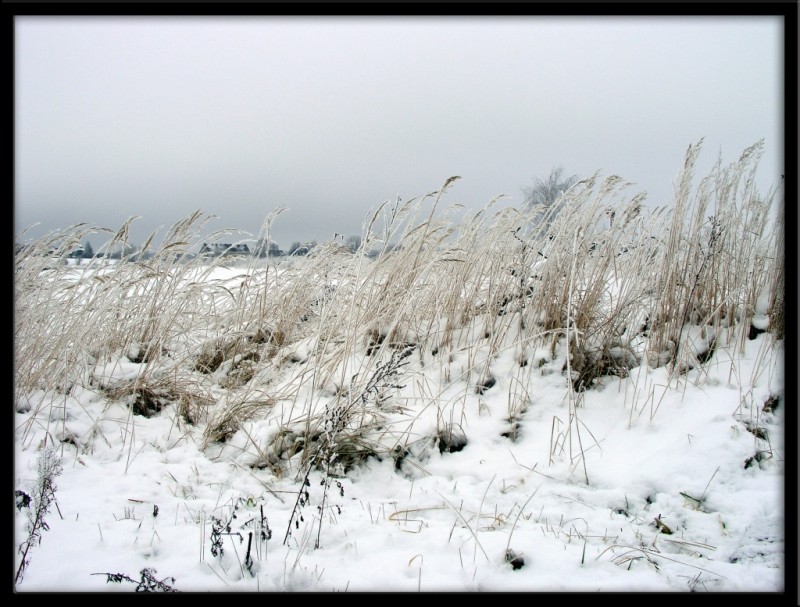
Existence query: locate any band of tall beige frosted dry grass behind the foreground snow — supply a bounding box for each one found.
[14,147,784,480]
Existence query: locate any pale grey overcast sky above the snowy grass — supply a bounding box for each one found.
[14,16,784,248]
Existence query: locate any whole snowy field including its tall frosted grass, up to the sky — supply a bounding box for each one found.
[14,145,785,592]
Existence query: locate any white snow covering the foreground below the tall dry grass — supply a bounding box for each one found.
[15,324,786,592]
